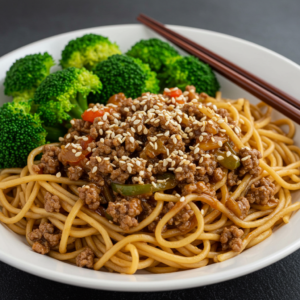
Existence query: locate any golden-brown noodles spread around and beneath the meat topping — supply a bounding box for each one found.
[0,92,300,274]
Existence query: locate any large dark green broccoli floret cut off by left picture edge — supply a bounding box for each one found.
[0,101,47,169]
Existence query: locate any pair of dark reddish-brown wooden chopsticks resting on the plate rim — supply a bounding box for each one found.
[137,14,300,124]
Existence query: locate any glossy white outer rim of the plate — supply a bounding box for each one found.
[0,24,300,292]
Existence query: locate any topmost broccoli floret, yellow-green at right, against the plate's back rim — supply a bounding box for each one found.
[60,33,121,70]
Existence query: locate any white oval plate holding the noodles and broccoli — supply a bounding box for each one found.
[0,25,300,291]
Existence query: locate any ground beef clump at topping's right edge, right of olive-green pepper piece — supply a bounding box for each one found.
[239,148,262,177]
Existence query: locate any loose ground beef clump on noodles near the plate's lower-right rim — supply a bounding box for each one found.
[220,226,244,252]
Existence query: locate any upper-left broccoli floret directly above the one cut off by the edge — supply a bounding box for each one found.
[4,52,54,102]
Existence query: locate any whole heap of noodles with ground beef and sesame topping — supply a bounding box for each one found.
[0,87,300,274]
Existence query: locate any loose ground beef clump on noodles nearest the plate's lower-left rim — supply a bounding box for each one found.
[28,223,61,254]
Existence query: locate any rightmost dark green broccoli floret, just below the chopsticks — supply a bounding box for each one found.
[162,56,220,96]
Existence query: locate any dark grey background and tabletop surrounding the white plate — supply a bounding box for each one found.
[0,0,300,300]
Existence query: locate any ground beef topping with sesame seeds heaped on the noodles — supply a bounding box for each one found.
[49,86,261,232]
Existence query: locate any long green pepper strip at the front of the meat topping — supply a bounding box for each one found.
[111,173,177,196]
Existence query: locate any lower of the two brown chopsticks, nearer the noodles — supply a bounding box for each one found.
[137,15,300,124]
